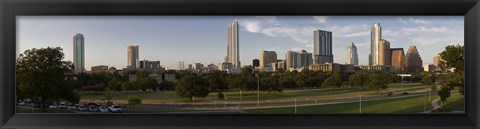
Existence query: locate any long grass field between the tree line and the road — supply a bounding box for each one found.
[80,83,429,104]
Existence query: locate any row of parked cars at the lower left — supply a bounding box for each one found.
[48,103,122,113]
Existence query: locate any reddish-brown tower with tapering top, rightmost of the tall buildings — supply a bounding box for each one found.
[405,46,422,73]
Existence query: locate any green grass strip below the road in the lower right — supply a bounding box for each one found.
[243,93,464,114]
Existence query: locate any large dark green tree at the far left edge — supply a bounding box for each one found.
[15,47,77,107]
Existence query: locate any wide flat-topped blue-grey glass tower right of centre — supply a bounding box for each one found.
[313,30,333,64]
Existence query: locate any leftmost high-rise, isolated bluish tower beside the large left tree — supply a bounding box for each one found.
[73,34,85,73]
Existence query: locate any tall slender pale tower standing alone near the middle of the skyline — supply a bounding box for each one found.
[226,19,240,71]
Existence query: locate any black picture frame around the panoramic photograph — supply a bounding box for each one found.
[0,0,480,129]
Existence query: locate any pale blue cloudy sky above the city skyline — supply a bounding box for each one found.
[16,16,464,70]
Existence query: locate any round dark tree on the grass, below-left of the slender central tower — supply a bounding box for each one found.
[175,75,210,102]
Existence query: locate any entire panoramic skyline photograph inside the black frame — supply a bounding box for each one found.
[15,16,465,114]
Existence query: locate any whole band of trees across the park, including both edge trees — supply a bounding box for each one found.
[16,45,464,106]
